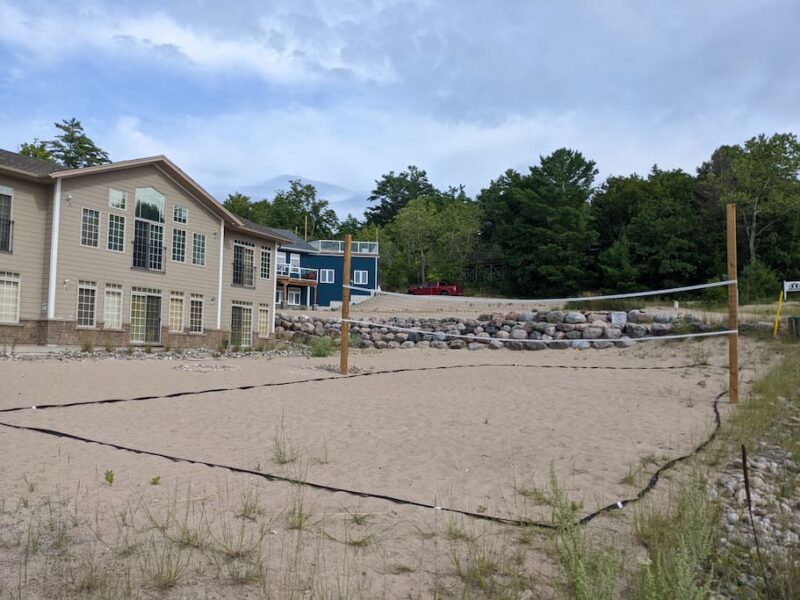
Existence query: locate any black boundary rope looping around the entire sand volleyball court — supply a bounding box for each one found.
[0,365,725,530]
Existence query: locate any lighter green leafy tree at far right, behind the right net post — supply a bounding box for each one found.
[698,133,800,263]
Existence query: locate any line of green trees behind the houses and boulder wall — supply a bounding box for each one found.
[21,119,800,302]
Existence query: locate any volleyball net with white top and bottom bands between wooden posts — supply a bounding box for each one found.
[342,280,737,350]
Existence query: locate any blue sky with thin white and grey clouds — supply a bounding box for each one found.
[0,0,800,216]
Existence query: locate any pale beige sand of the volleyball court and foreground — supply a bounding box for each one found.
[0,340,766,598]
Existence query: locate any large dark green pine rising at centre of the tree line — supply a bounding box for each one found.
[479,148,597,295]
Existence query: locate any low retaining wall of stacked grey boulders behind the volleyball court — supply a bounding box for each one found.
[275,310,709,350]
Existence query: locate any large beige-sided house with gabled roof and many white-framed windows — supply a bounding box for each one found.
[0,150,287,348]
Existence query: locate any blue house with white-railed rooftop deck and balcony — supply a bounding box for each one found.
[260,228,378,308]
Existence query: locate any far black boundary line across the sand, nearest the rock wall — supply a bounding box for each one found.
[0,363,713,414]
